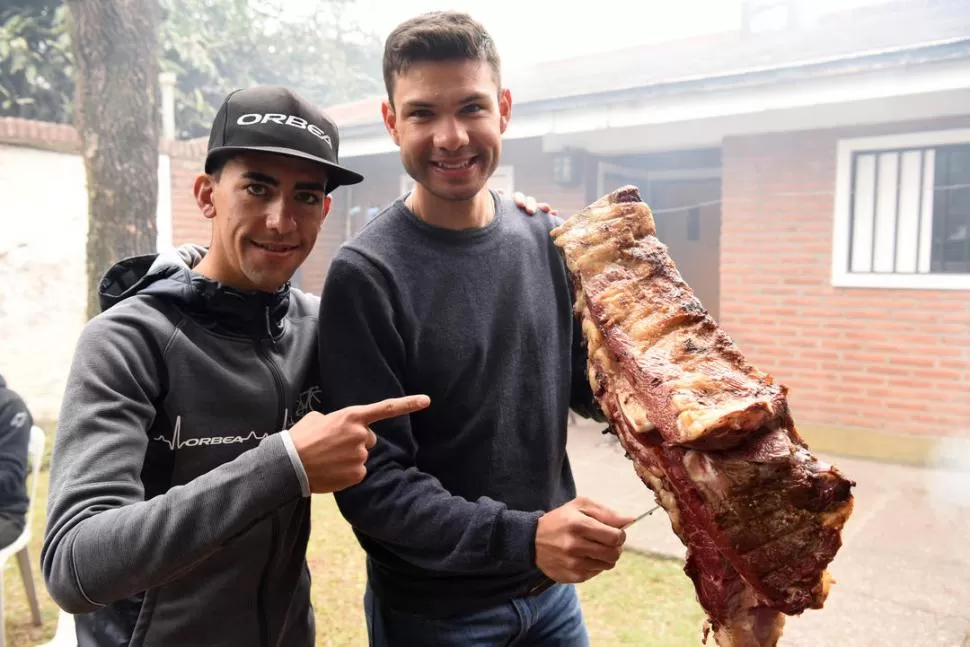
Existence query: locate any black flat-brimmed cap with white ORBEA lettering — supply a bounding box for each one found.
[205,85,364,193]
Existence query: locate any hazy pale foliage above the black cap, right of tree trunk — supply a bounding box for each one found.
[161,0,382,138]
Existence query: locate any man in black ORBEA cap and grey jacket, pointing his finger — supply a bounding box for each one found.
[41,87,429,647]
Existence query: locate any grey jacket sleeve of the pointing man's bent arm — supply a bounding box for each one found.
[41,319,302,613]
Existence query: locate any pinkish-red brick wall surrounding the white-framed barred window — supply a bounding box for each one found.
[721,119,970,435]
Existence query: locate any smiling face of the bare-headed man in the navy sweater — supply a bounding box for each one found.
[382,59,512,202]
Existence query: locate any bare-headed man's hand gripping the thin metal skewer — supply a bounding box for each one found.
[536,497,635,584]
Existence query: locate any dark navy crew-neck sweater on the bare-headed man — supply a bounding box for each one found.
[319,198,600,616]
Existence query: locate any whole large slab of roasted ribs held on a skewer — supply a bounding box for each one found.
[552,187,855,647]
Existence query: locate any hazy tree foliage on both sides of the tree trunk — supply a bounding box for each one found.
[0,0,381,138]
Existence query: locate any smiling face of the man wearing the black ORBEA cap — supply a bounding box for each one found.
[195,153,331,292]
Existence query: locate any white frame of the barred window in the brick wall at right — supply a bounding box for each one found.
[832,128,970,290]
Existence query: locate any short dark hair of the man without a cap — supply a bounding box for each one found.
[384,11,501,106]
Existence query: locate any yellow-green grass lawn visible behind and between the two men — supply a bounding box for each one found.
[3,436,703,647]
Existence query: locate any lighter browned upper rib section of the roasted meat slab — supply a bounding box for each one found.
[554,187,788,449]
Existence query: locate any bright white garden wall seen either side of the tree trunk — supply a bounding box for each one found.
[0,144,172,419]
